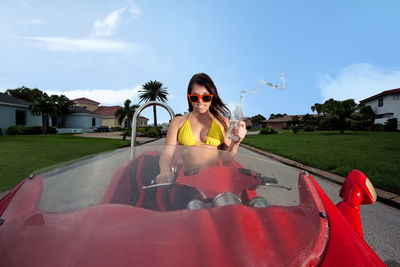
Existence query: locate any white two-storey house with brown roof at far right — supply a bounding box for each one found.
[360,88,400,129]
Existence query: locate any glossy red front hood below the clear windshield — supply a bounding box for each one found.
[0,177,328,266]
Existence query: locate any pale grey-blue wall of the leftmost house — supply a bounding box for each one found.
[0,105,42,134]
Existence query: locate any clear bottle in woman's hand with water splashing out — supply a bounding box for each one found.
[227,70,287,142]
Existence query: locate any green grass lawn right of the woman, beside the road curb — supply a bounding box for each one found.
[243,131,400,193]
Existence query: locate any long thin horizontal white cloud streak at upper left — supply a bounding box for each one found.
[25,37,151,53]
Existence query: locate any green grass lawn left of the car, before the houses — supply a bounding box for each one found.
[0,134,130,192]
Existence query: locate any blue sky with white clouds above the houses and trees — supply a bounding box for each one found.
[0,0,400,124]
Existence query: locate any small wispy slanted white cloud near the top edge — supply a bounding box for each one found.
[90,5,141,37]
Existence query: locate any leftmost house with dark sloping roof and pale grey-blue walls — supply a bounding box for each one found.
[0,93,42,135]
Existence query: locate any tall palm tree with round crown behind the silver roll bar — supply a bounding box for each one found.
[139,81,168,127]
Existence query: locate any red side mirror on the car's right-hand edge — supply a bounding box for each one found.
[336,170,376,238]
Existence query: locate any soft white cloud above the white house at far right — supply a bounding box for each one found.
[318,63,400,101]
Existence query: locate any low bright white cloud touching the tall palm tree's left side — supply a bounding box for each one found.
[45,86,141,106]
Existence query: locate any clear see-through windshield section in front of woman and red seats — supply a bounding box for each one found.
[37,145,324,215]
